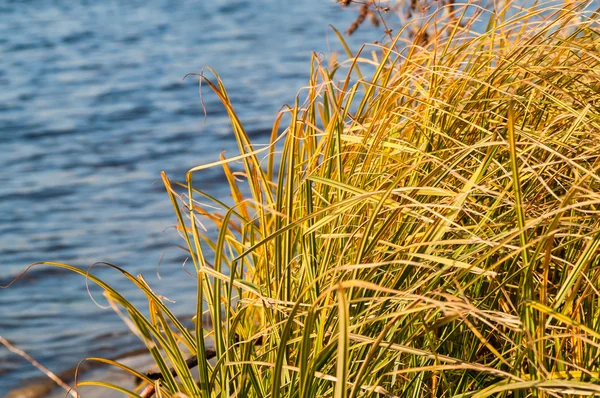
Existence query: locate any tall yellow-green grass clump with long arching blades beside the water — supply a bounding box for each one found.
[14,3,600,398]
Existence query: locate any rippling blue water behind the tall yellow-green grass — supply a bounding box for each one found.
[0,0,382,396]
